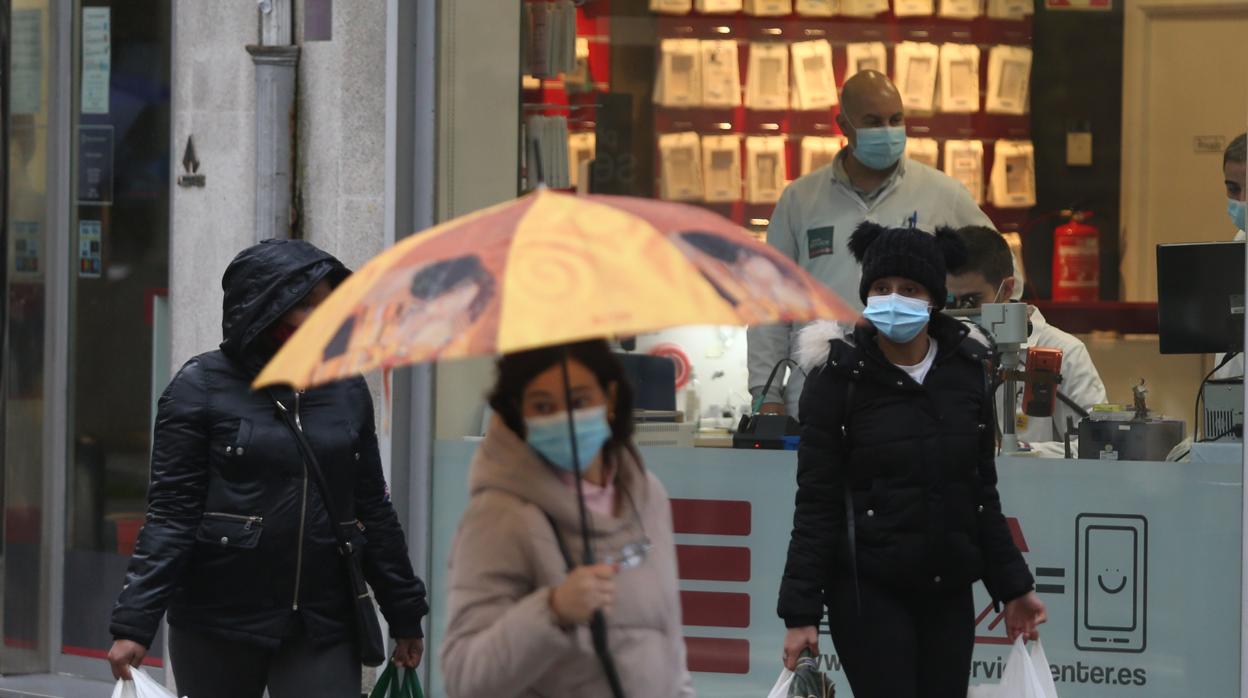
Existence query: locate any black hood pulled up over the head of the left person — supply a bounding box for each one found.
[221,240,351,371]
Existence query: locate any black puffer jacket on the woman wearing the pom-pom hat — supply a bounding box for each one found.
[779,313,1033,628]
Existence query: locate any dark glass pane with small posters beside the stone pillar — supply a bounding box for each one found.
[62,0,172,663]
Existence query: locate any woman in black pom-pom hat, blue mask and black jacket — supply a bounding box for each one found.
[779,224,1046,698]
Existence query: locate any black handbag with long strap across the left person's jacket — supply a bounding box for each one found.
[268,393,386,667]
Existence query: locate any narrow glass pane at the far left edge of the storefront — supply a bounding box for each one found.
[0,0,57,673]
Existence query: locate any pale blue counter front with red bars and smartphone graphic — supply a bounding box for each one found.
[429,441,1242,698]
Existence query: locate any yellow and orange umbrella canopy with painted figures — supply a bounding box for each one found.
[255,191,856,388]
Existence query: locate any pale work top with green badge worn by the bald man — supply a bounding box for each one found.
[746,149,993,417]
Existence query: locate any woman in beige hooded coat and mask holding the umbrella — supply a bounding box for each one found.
[442,341,693,698]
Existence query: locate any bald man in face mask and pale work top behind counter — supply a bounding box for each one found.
[748,70,992,417]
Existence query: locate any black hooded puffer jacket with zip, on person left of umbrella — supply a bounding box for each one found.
[110,241,428,647]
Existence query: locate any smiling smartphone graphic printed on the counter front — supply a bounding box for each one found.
[1075,513,1148,653]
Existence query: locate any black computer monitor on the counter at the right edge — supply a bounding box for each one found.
[1157,242,1244,353]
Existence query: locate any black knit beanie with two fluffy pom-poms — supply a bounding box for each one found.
[849,221,966,310]
